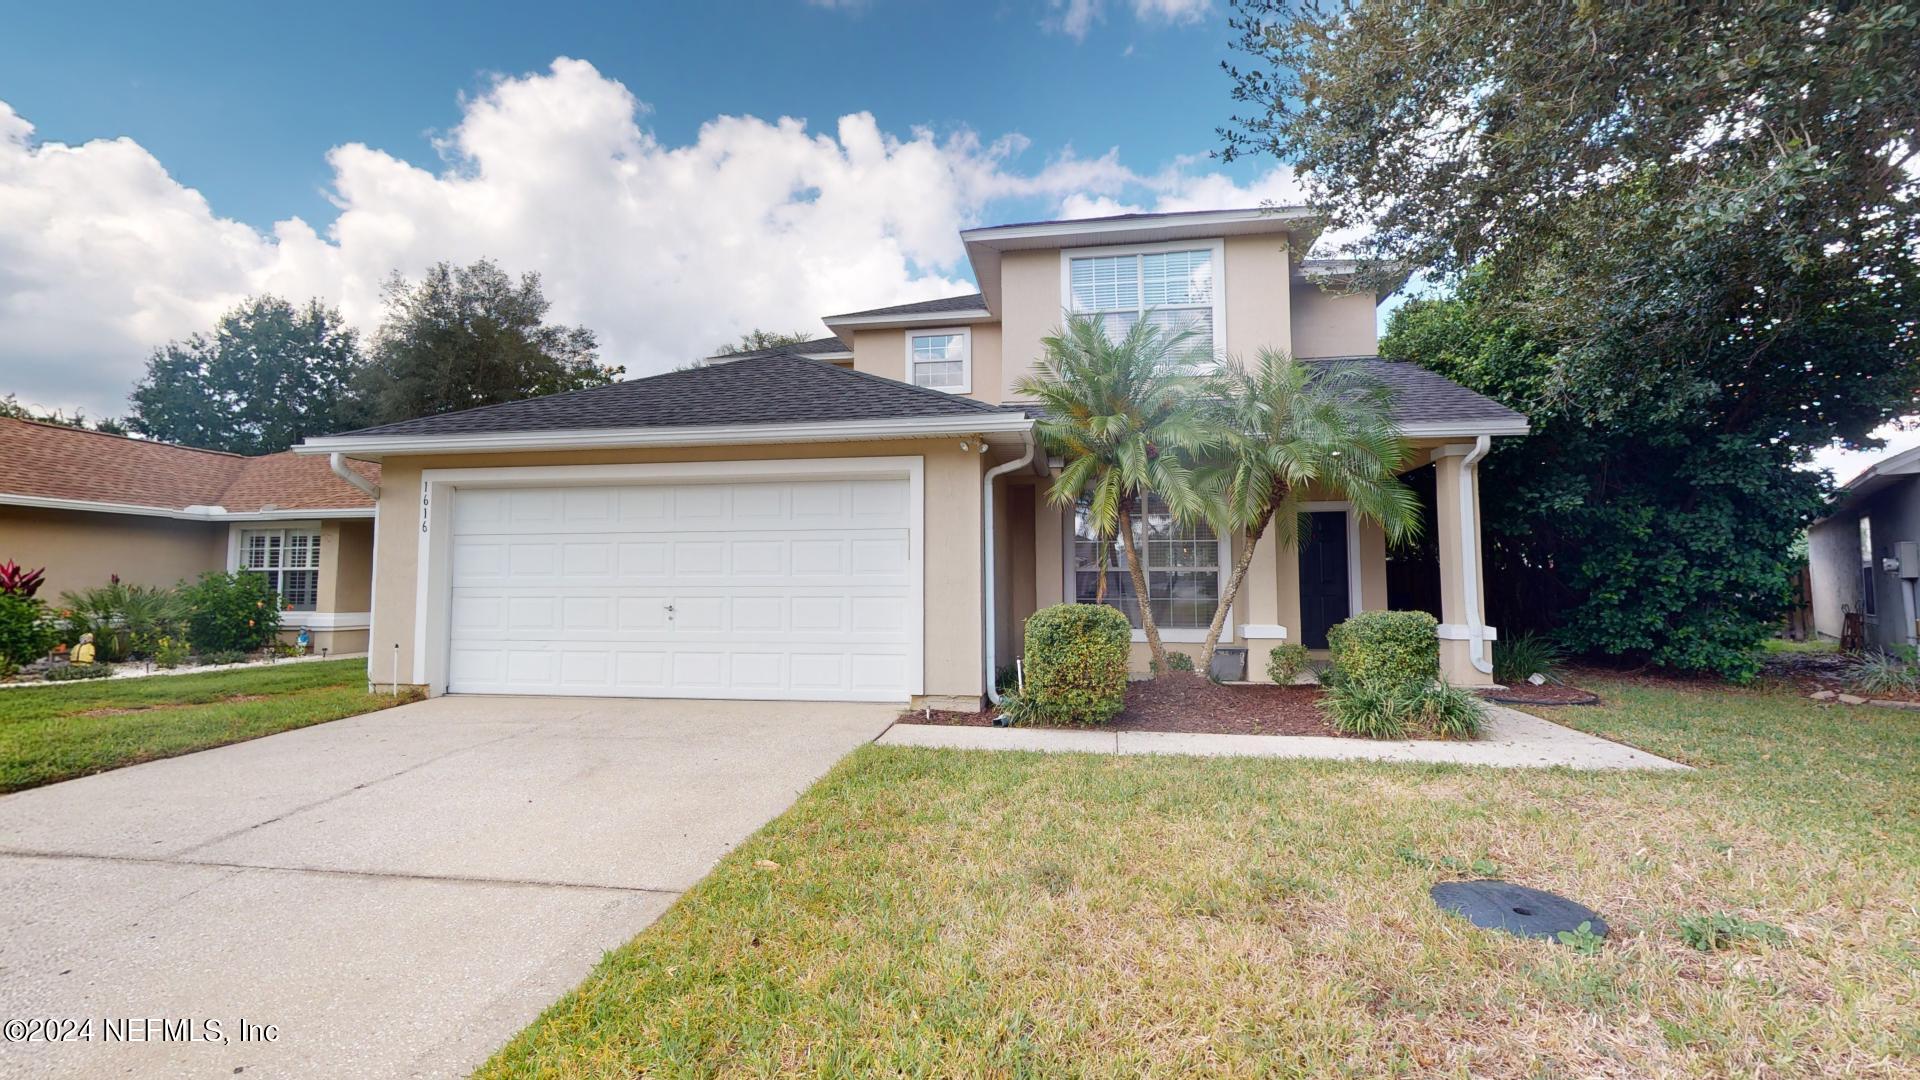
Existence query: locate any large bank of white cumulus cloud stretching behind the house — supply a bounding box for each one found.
[0,58,1286,415]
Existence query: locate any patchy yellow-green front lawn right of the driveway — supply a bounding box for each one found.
[480,684,1920,1076]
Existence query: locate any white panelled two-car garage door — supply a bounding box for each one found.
[447,479,920,701]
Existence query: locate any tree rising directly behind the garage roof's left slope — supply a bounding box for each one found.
[357,259,626,423]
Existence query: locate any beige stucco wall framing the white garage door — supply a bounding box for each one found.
[369,438,989,703]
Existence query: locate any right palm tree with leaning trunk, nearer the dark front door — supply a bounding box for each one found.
[1200,350,1421,671]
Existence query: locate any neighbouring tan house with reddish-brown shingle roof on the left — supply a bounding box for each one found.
[0,419,380,653]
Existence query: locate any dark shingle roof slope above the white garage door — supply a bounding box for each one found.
[332,356,1000,436]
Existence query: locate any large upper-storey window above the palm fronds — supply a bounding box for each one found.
[1066,246,1221,356]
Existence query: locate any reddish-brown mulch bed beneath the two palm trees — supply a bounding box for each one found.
[900,671,1346,738]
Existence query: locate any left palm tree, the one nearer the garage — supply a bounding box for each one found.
[1016,307,1219,673]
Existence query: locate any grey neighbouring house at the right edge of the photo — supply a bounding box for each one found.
[1807,450,1920,650]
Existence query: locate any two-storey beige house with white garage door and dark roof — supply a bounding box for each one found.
[298,209,1526,707]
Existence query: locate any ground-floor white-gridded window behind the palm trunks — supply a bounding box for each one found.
[1073,496,1225,630]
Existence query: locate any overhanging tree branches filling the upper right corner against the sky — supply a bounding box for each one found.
[1223,0,1920,440]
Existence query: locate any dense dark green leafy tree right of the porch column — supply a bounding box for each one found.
[1380,279,1824,678]
